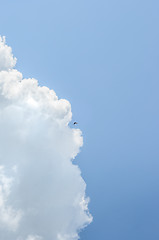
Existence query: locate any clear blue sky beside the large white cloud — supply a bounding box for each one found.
[0,0,159,240]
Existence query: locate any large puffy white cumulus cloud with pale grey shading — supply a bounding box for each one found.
[0,38,92,240]
